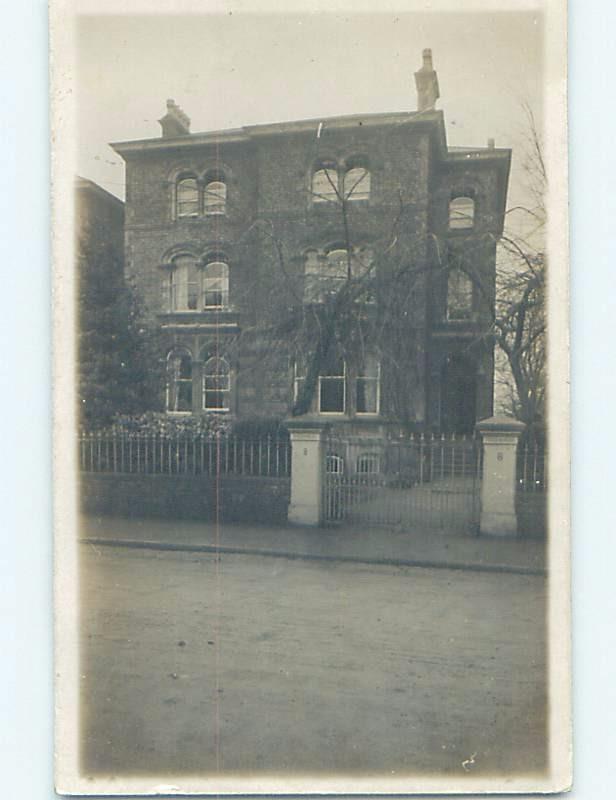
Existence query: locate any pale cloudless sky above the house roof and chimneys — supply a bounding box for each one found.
[76,11,544,205]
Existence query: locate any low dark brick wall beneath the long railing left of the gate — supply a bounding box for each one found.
[80,472,290,523]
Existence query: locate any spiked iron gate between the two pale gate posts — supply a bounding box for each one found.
[323,435,481,533]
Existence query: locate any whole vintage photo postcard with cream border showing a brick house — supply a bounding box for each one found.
[50,0,571,796]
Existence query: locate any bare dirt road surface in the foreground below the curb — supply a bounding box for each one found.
[81,544,546,776]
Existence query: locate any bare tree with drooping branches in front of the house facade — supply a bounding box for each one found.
[233,164,428,423]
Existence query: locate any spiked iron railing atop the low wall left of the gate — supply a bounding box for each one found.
[79,431,291,478]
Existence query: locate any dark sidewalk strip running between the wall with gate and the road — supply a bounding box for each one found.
[80,516,545,574]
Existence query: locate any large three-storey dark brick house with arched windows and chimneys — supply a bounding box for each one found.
[112,50,511,432]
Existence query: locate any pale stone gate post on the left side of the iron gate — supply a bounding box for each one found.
[287,417,326,526]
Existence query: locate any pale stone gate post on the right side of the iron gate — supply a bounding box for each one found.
[477,416,525,536]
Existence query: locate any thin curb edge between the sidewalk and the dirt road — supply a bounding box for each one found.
[79,537,547,577]
